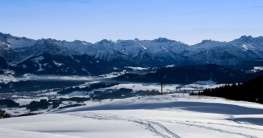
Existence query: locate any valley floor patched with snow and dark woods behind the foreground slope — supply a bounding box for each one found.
[0,72,224,117]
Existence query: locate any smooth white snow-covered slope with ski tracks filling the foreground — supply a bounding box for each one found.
[0,94,263,138]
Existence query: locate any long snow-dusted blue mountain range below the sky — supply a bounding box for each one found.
[0,33,263,74]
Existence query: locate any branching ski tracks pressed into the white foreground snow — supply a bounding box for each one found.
[68,113,263,138]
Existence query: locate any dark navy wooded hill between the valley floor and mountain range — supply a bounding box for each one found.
[114,64,258,84]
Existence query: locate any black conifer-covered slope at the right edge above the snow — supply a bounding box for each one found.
[194,76,263,103]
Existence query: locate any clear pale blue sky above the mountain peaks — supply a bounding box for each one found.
[0,0,263,44]
